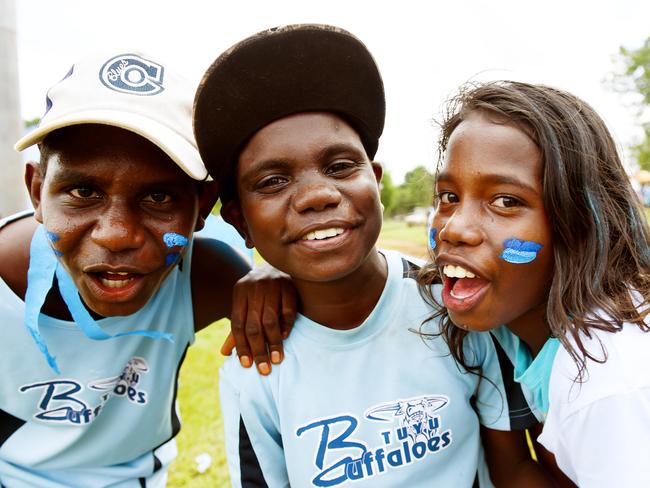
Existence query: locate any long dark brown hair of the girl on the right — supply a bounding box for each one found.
[418,81,650,377]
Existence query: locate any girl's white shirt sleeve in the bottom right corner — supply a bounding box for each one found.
[539,388,650,488]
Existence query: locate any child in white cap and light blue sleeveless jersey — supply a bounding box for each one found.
[0,52,294,488]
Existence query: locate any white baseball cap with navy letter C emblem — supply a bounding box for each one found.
[14,51,208,180]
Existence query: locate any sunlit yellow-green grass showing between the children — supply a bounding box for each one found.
[167,220,427,488]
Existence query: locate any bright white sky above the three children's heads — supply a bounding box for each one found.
[16,0,650,182]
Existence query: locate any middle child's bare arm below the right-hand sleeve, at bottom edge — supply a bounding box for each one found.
[481,426,557,488]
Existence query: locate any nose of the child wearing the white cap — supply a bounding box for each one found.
[91,204,144,252]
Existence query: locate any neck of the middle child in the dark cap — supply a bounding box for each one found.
[294,249,388,330]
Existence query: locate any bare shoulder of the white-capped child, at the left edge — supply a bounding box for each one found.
[0,212,38,298]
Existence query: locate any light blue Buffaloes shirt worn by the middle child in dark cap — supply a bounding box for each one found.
[220,251,532,488]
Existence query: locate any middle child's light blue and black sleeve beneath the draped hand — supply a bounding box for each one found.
[219,355,289,488]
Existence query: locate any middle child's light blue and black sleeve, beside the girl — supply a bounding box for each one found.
[465,332,539,430]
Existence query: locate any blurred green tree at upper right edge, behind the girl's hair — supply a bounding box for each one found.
[613,37,650,170]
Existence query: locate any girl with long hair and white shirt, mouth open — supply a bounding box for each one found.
[419,81,650,487]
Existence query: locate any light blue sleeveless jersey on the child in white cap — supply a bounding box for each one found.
[0,214,194,488]
